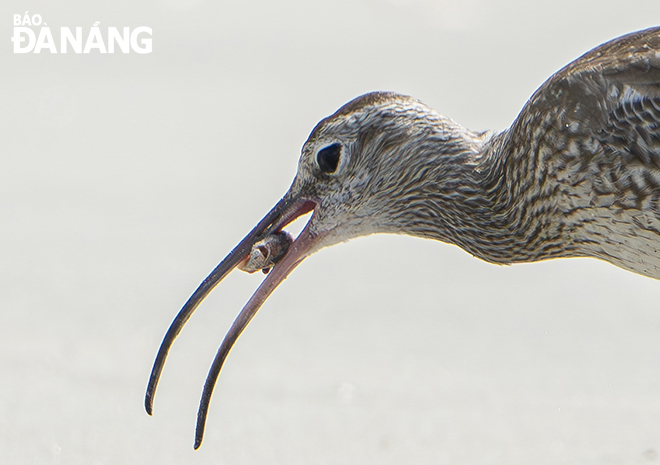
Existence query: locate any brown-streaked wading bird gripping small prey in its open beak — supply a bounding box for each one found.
[145,27,660,449]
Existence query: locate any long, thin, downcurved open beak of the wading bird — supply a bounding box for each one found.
[144,194,322,449]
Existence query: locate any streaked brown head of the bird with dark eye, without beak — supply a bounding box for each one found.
[278,92,477,254]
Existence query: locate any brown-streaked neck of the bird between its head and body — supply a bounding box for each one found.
[386,127,576,264]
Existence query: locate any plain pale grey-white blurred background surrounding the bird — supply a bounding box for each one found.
[0,0,660,465]
